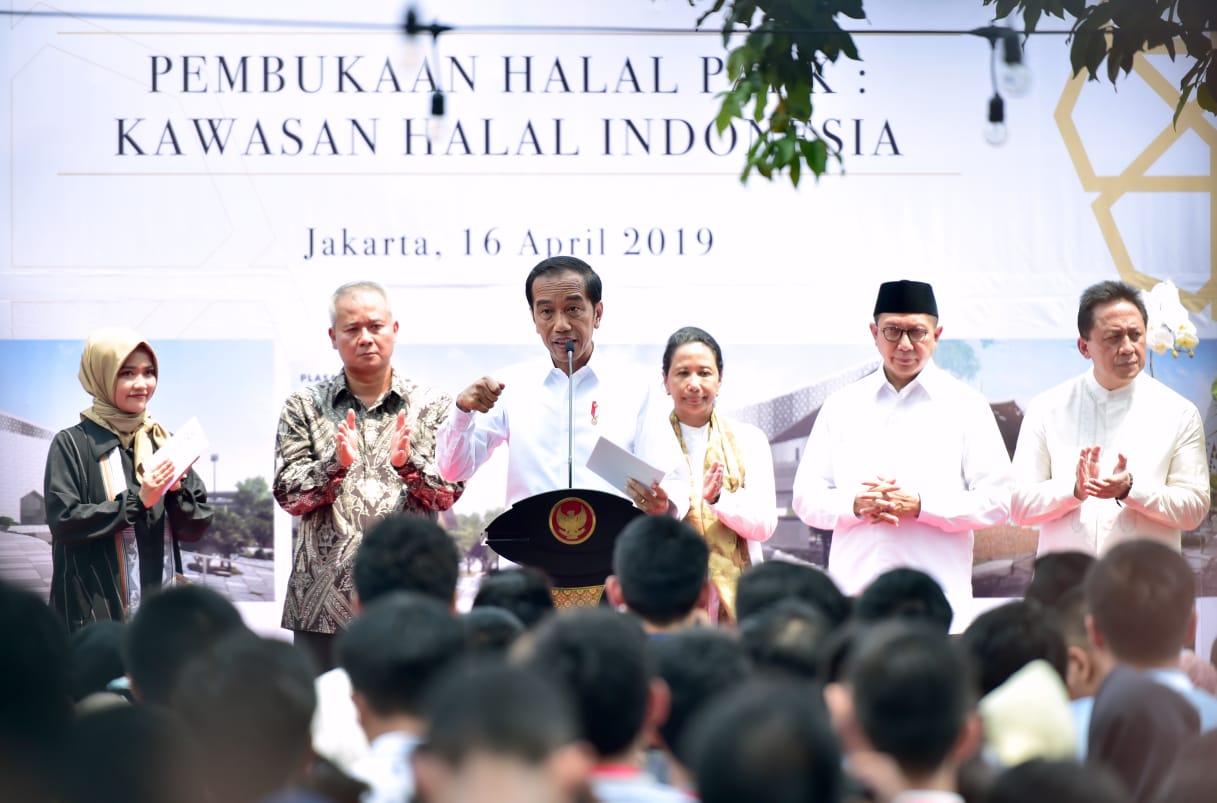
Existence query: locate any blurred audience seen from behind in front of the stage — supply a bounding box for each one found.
[7,513,1217,803]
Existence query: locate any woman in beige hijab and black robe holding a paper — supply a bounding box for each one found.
[44,329,212,631]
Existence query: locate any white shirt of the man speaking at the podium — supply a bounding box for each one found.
[436,358,658,505]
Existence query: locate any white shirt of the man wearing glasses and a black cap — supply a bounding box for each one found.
[793,363,1011,611]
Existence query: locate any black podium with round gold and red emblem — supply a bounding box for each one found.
[486,488,643,607]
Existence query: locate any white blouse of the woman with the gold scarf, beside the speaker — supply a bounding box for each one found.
[639,412,778,563]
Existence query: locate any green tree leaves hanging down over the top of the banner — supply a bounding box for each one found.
[689,0,1217,186]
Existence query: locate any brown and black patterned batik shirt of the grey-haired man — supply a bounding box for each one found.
[274,371,464,633]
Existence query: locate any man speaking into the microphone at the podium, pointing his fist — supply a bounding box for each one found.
[436,257,667,510]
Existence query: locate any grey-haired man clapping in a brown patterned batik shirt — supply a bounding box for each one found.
[274,281,464,672]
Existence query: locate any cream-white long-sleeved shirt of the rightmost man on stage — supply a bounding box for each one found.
[1010,371,1208,555]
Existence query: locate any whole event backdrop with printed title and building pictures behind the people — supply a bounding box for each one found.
[0,0,1217,650]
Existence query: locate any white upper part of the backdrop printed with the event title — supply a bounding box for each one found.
[0,0,1217,637]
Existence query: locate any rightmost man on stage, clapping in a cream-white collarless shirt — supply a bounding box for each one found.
[1010,281,1208,555]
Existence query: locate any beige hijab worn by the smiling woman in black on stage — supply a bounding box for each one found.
[78,329,169,482]
